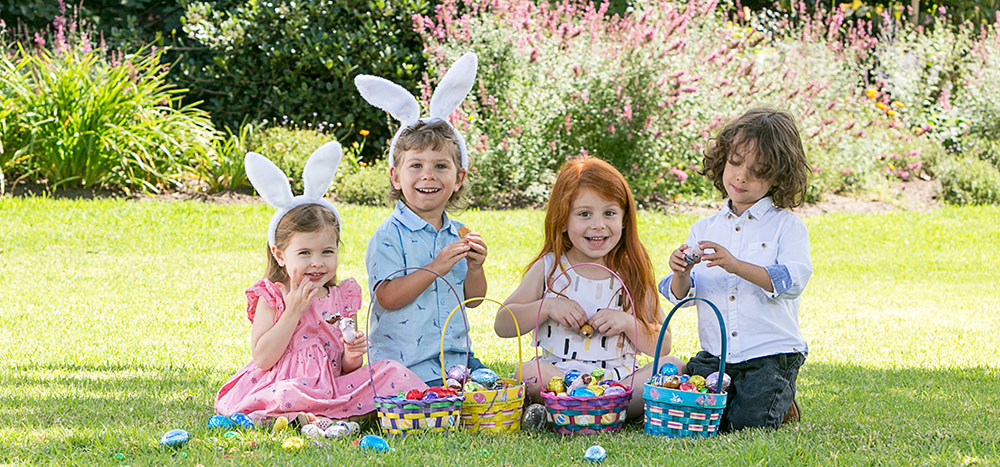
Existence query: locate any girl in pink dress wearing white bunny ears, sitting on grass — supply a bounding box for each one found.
[215,142,427,422]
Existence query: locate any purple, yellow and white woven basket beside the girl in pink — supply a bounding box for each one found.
[365,267,469,436]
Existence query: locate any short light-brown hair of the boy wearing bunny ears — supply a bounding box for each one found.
[387,120,472,209]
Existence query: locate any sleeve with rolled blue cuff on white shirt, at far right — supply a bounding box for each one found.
[765,216,812,299]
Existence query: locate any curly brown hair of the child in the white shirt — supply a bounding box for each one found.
[701,108,811,209]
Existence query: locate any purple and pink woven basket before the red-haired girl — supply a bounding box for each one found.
[535,263,639,435]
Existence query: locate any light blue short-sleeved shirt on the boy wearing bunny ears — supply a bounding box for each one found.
[365,201,468,382]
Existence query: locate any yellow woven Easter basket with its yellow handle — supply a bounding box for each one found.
[441,298,525,433]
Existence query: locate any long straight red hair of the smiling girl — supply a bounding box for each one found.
[528,157,659,331]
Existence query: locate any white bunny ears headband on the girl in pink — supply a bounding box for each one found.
[243,141,344,247]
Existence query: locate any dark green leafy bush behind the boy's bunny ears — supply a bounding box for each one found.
[178,0,428,160]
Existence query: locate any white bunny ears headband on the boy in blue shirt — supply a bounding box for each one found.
[354,52,478,170]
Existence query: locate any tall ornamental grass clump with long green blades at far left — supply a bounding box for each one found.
[0,40,215,192]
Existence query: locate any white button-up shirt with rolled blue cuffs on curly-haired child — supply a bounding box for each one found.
[659,197,812,363]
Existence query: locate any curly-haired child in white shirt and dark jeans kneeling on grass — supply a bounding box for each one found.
[659,109,812,431]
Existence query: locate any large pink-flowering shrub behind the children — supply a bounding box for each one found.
[415,0,936,205]
